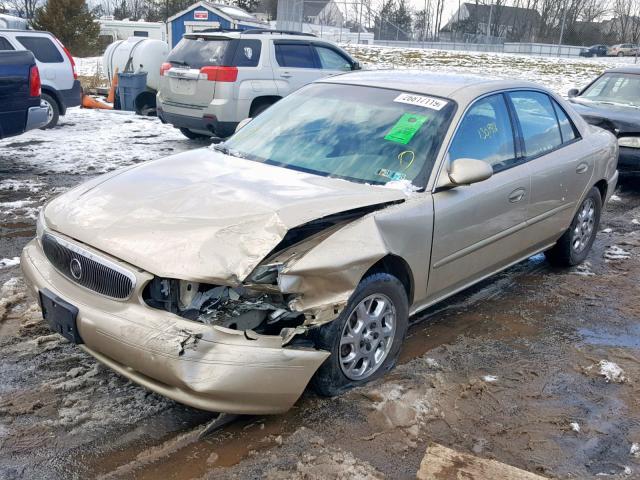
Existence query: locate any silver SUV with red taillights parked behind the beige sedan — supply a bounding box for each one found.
[157,30,360,139]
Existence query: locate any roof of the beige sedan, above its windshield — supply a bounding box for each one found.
[317,70,546,103]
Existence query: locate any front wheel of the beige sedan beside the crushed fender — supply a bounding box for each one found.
[311,273,409,397]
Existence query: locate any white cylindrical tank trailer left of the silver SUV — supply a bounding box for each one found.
[102,37,169,115]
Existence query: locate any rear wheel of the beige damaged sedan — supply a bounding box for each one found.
[545,187,602,267]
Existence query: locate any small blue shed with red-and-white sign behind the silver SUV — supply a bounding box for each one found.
[167,0,269,48]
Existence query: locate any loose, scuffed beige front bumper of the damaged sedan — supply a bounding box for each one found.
[21,240,329,414]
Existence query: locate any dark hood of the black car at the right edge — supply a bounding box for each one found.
[569,97,640,134]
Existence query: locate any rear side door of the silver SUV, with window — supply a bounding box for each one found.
[272,40,325,97]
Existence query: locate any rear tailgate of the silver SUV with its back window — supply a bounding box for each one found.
[161,35,237,108]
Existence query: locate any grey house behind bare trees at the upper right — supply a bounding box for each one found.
[440,3,541,42]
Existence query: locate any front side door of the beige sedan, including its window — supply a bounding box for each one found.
[428,94,530,300]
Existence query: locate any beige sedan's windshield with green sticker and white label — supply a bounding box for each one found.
[219,84,455,186]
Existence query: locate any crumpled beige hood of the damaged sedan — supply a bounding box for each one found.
[44,148,406,284]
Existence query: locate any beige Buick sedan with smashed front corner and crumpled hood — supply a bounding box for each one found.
[22,72,618,414]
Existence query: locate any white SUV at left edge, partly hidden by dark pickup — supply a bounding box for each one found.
[0,29,82,128]
